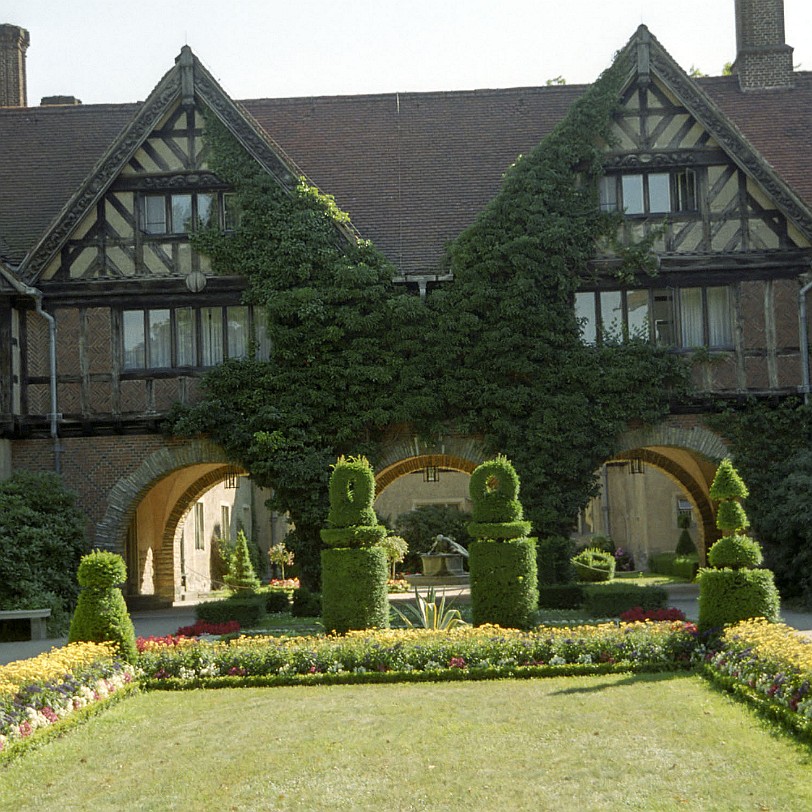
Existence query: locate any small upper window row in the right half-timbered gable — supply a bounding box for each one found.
[599,169,698,215]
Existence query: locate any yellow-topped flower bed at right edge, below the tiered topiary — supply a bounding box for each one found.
[704,618,812,739]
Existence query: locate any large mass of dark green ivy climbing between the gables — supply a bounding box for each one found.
[170,58,680,585]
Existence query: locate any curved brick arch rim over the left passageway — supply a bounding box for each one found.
[96,440,235,555]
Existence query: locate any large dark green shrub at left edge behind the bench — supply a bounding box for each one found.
[0,471,88,620]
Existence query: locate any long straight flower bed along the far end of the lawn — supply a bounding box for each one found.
[139,622,696,688]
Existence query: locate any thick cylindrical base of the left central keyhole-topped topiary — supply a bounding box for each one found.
[321,545,389,634]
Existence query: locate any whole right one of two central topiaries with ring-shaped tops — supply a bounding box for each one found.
[468,455,538,628]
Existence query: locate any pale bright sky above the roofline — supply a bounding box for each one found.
[0,0,812,105]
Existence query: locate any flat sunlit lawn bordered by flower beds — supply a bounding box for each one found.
[0,675,812,812]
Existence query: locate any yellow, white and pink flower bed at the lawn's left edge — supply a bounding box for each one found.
[0,643,135,756]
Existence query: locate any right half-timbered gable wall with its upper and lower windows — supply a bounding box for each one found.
[576,26,812,394]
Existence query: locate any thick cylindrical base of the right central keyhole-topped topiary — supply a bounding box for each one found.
[469,538,538,629]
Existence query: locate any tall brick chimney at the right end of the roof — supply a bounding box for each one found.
[733,0,794,91]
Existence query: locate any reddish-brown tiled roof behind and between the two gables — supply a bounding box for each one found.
[0,72,812,274]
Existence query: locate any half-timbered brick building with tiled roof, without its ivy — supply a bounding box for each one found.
[0,0,812,601]
